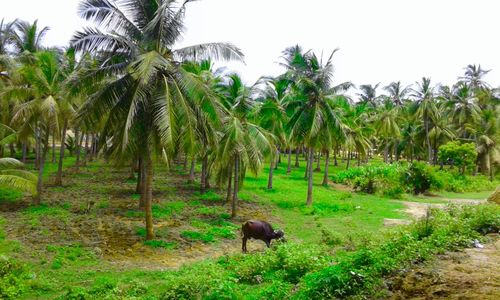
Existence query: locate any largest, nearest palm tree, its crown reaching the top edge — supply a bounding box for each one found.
[72,0,243,240]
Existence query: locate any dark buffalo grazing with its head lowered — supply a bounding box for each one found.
[241,220,285,253]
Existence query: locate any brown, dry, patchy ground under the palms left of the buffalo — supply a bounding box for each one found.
[0,163,279,269]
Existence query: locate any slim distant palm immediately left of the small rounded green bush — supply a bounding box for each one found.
[413,77,437,163]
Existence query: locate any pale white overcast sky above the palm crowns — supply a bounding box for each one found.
[0,0,500,90]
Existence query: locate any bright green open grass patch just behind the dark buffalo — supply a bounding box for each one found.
[241,162,405,242]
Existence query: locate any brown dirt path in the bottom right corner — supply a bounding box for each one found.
[388,235,500,300]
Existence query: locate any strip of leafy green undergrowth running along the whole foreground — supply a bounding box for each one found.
[0,205,500,299]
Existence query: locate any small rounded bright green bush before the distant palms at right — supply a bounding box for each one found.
[438,141,477,173]
